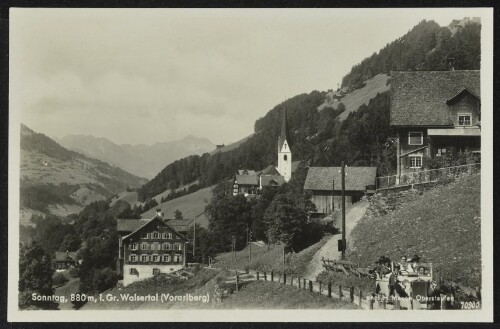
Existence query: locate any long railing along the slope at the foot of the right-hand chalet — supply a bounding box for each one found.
[376,163,481,190]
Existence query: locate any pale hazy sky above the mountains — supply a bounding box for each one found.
[9,8,486,145]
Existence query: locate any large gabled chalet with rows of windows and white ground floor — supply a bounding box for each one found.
[117,213,189,286]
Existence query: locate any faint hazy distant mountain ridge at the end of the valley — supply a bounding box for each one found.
[55,135,215,178]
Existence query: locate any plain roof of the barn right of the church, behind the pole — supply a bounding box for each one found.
[304,167,377,191]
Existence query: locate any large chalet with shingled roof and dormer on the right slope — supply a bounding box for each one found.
[390,70,481,182]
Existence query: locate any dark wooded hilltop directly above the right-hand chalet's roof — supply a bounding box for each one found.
[341,18,481,90]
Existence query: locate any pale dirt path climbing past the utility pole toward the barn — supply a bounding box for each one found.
[306,201,368,282]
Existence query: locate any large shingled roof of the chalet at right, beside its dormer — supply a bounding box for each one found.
[391,71,481,126]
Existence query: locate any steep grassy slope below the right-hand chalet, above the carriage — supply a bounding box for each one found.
[348,175,481,287]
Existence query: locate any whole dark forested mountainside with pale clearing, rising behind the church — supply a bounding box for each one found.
[138,21,481,201]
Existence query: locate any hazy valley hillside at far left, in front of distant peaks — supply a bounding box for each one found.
[20,125,146,217]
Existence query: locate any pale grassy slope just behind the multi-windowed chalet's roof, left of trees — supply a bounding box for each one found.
[141,187,212,227]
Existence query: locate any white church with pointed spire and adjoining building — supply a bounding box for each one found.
[233,110,298,197]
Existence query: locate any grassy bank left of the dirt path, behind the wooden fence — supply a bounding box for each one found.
[217,235,331,276]
